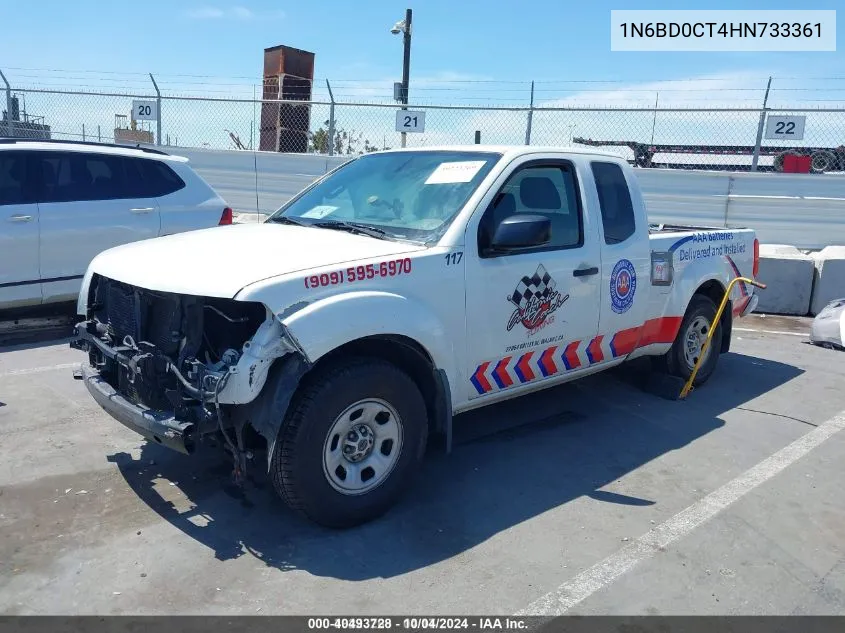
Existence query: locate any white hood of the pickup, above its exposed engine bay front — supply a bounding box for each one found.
[86,223,425,298]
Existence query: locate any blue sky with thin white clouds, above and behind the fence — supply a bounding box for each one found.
[0,0,845,153]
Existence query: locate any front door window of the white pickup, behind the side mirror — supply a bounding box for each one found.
[478,163,583,253]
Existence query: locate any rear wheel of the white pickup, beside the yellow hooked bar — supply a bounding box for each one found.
[655,295,723,386]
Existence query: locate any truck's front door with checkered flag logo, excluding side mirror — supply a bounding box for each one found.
[465,159,601,398]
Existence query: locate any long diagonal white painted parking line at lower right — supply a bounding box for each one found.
[516,411,845,616]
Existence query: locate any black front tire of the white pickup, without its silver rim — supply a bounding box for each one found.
[270,358,428,528]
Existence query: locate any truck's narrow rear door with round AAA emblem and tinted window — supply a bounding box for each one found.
[584,160,654,350]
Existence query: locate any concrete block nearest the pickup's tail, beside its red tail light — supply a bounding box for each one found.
[755,244,815,316]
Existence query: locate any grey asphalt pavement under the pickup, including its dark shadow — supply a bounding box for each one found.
[0,317,845,615]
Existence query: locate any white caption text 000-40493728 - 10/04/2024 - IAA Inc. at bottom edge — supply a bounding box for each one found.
[308,616,528,631]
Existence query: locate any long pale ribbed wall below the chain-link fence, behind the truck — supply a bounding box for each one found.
[164,147,845,249]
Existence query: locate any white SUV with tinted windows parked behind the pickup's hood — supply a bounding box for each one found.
[0,139,232,309]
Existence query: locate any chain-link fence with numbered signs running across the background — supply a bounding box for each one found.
[0,84,845,172]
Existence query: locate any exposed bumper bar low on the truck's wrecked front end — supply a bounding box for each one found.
[82,363,195,455]
